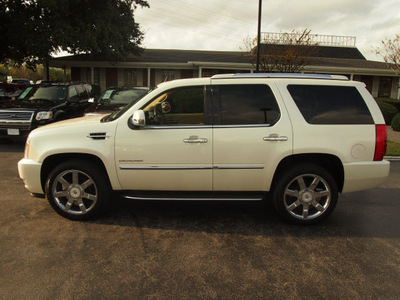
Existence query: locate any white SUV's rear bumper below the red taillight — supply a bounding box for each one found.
[342,160,390,193]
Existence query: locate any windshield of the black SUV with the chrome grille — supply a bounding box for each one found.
[18,86,68,101]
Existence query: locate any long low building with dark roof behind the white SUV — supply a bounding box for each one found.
[49,35,399,99]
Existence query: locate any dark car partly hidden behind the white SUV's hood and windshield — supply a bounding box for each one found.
[85,87,149,116]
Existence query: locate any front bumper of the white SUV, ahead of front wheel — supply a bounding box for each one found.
[18,158,44,194]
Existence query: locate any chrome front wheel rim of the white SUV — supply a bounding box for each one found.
[51,170,99,215]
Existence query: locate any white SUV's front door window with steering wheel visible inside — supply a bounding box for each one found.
[143,86,205,126]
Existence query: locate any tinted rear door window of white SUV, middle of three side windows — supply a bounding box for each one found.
[217,84,280,125]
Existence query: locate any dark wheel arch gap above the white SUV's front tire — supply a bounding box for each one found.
[40,153,111,191]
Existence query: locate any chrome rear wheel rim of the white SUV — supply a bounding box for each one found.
[283,174,332,220]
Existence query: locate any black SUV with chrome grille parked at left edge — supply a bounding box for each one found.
[0,83,92,137]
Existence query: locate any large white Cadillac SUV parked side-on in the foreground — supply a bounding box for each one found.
[18,74,390,224]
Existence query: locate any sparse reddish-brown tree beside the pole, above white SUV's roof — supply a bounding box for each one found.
[244,29,318,73]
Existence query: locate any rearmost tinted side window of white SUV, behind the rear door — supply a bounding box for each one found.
[288,85,374,124]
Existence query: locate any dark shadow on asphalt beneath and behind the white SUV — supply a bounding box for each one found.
[90,189,400,239]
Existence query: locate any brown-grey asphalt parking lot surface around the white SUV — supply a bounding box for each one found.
[0,140,400,299]
